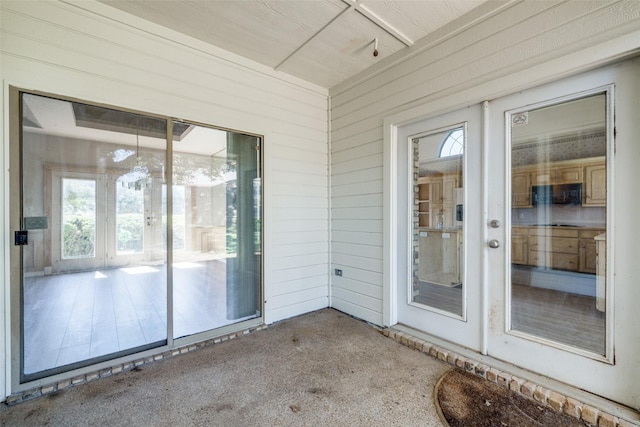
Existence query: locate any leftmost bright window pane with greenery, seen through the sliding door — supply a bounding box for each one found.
[62,178,96,259]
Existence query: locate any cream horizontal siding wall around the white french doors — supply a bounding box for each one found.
[330,0,640,325]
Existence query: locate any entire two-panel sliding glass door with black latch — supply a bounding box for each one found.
[16,91,262,383]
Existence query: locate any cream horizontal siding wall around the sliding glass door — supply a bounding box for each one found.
[0,1,329,344]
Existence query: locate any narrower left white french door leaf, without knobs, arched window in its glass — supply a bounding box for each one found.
[395,105,483,350]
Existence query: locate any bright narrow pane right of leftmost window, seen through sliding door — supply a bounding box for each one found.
[116,185,144,255]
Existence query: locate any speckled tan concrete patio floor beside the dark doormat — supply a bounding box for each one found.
[0,309,451,426]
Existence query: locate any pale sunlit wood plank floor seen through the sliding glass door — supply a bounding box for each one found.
[24,260,252,374]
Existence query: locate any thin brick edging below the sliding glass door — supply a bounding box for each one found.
[5,325,267,405]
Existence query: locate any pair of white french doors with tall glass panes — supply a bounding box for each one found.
[394,60,640,408]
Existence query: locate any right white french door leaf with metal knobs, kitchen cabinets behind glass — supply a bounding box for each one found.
[485,62,639,407]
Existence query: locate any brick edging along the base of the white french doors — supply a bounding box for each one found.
[382,328,640,427]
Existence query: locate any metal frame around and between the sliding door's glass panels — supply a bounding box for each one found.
[5,85,265,395]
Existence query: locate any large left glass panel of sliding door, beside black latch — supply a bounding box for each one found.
[21,94,167,381]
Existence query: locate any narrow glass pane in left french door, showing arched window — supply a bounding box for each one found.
[411,126,465,316]
